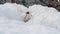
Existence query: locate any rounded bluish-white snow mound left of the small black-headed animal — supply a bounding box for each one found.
[0,3,27,20]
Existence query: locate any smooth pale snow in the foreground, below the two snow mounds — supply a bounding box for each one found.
[0,17,60,34]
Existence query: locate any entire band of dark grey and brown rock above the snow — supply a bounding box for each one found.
[0,0,60,11]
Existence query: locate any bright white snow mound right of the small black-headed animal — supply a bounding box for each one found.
[29,5,60,29]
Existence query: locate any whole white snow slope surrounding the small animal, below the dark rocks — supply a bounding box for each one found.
[0,3,60,34]
